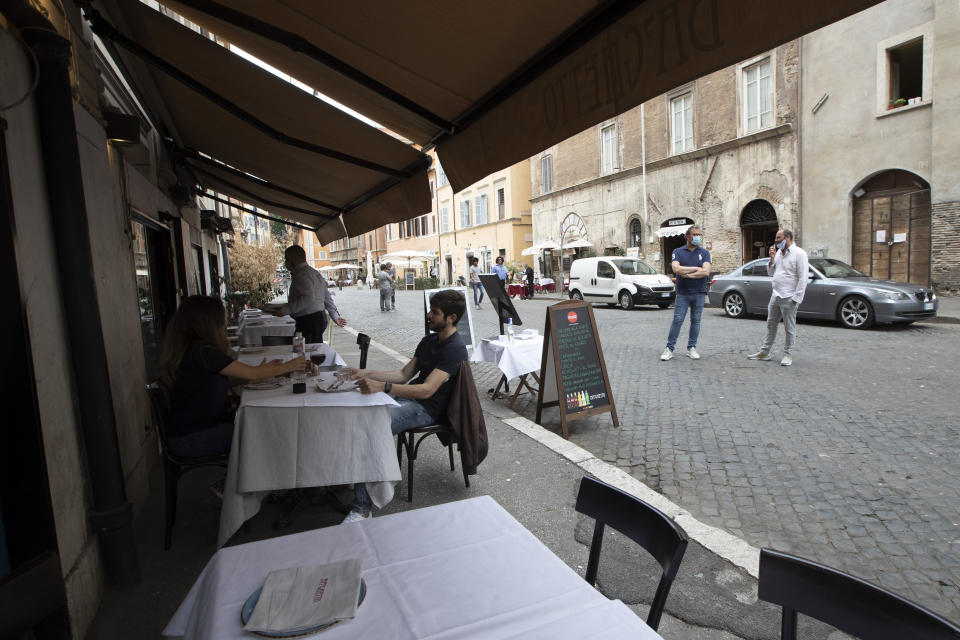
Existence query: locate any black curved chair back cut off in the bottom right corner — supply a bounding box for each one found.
[757,549,960,640]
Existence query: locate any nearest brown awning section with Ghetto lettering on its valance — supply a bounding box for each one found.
[159,0,879,191]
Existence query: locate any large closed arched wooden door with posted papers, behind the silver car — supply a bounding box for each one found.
[852,169,930,286]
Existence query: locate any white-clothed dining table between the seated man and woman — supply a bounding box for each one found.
[217,343,400,546]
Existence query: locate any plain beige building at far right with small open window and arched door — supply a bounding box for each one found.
[801,0,960,293]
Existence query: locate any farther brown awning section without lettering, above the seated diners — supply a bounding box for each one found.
[94,2,430,242]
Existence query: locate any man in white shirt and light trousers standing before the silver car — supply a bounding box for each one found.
[747,229,809,367]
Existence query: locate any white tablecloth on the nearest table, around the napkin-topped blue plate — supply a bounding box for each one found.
[163,496,660,640]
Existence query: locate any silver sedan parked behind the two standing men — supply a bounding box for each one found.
[709,258,939,329]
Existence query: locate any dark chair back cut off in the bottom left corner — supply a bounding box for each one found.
[0,551,70,640]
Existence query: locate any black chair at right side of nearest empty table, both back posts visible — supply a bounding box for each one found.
[575,476,687,631]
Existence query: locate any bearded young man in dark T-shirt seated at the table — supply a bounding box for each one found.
[343,289,467,523]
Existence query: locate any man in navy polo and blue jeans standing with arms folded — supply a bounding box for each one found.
[660,227,710,360]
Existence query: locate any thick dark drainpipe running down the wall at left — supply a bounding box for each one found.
[22,27,140,586]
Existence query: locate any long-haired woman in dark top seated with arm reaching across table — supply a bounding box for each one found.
[160,296,304,457]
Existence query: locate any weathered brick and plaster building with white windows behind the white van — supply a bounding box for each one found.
[530,41,800,272]
